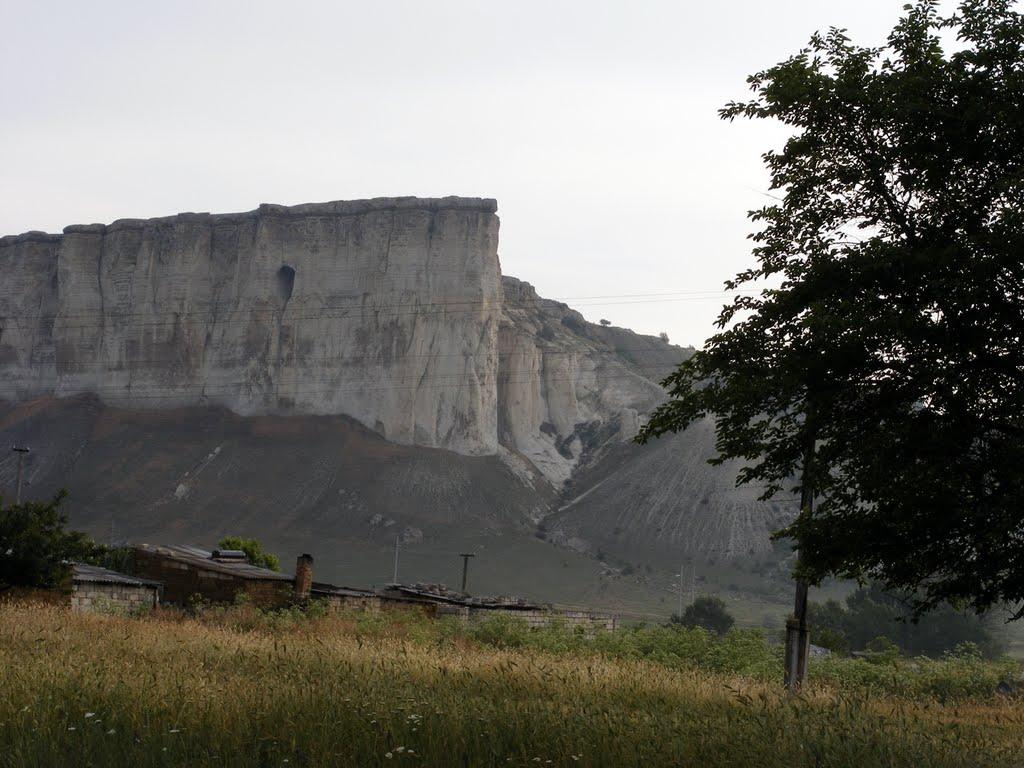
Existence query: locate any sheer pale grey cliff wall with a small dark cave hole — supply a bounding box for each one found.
[0,198,502,455]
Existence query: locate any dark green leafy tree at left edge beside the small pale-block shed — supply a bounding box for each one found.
[0,490,100,589]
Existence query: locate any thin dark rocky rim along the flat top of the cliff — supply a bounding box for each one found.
[0,196,498,248]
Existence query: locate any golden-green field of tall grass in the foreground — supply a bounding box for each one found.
[0,604,1024,768]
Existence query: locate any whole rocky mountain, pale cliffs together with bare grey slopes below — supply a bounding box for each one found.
[0,198,782,557]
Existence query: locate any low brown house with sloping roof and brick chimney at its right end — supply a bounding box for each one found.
[132,544,313,608]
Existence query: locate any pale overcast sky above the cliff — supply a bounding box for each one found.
[0,0,937,346]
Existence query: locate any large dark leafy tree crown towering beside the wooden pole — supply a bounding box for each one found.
[638,0,1024,617]
